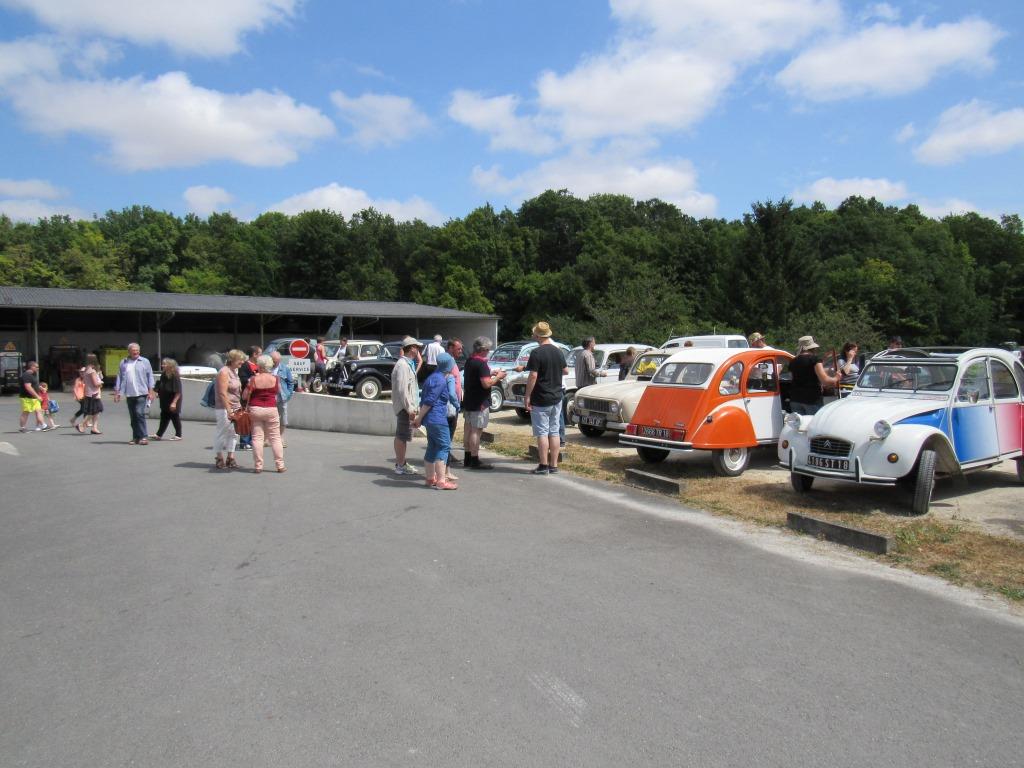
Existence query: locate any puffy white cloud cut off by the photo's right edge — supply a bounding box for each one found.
[913,100,1024,165]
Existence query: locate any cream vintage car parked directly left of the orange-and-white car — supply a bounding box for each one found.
[569,349,673,437]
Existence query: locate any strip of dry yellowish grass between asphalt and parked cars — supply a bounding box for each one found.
[486,425,1024,602]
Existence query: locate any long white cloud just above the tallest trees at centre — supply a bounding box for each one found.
[473,142,718,217]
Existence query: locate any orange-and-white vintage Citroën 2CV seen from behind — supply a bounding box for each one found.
[618,347,793,477]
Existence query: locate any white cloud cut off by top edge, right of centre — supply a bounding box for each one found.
[611,0,842,60]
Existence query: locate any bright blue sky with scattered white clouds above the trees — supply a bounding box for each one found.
[0,0,1024,223]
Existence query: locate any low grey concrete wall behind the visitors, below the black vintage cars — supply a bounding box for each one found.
[181,379,394,435]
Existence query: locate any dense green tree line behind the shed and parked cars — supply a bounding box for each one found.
[0,191,1024,348]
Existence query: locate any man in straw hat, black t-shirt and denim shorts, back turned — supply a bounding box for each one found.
[525,322,568,475]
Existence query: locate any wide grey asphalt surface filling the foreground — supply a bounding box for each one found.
[0,397,1024,768]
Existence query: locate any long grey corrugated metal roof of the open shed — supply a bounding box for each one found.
[0,286,498,319]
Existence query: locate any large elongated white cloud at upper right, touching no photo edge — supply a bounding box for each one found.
[777,18,1002,101]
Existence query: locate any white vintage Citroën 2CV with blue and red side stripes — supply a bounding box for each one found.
[778,347,1024,514]
